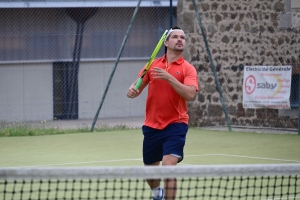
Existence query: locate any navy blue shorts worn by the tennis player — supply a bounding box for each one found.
[142,123,188,165]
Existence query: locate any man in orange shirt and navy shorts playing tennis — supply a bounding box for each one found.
[127,27,198,200]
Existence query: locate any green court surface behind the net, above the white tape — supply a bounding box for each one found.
[0,128,300,167]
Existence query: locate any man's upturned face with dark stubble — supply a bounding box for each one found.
[165,30,186,51]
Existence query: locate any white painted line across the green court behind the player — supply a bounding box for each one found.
[7,154,300,168]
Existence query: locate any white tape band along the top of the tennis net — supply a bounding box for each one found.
[0,164,300,179]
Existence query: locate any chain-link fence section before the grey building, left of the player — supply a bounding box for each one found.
[0,0,177,129]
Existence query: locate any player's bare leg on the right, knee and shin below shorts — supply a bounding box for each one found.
[162,155,179,200]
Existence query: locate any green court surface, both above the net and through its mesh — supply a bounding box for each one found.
[0,129,300,200]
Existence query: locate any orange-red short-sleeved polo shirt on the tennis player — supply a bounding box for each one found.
[139,55,198,129]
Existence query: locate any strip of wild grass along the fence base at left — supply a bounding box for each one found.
[0,121,130,137]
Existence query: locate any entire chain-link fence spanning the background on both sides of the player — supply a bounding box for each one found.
[0,0,300,132]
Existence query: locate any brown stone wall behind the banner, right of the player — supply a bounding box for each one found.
[177,0,300,128]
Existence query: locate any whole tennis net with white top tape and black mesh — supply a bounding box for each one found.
[0,164,300,200]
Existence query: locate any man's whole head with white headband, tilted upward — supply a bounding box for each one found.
[164,26,186,53]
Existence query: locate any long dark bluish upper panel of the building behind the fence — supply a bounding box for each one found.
[0,7,176,62]
